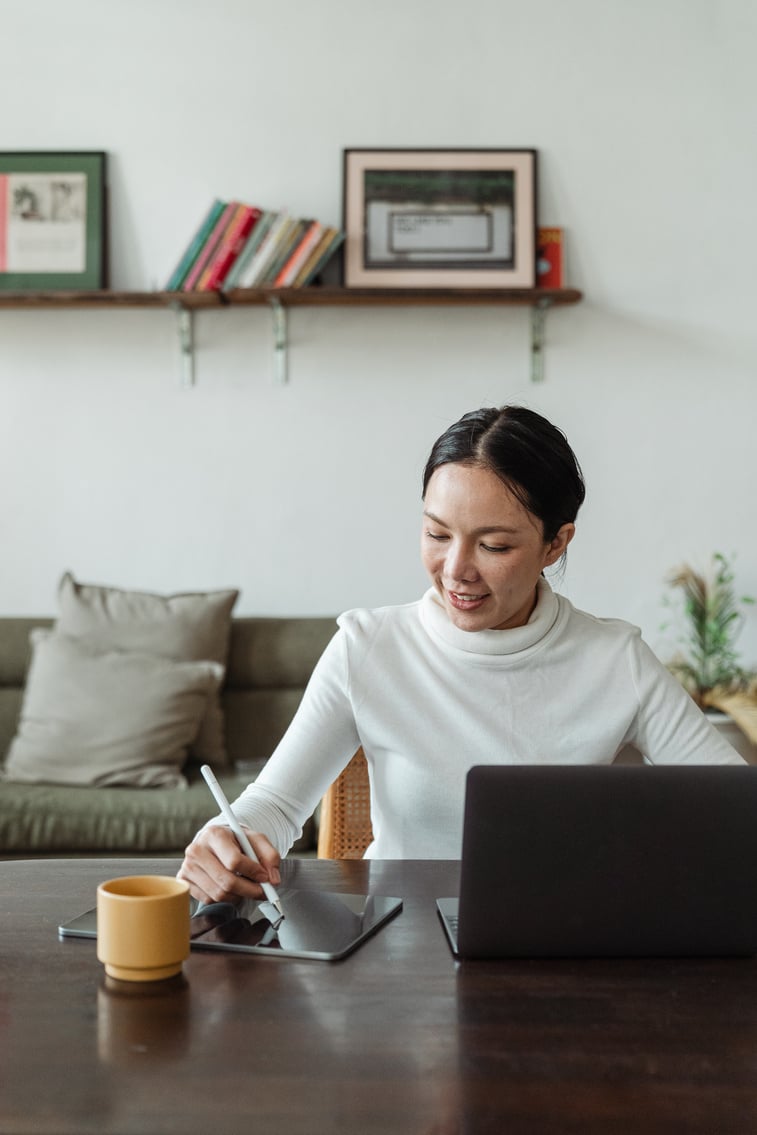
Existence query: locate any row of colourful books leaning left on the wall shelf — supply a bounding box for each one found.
[166,197,344,292]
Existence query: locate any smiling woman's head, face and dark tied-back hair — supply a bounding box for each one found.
[421,406,586,631]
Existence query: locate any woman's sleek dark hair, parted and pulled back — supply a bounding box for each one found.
[423,406,586,540]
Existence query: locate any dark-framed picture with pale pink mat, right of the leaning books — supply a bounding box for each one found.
[343,150,537,288]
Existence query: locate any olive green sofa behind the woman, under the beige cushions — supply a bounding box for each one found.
[0,617,336,859]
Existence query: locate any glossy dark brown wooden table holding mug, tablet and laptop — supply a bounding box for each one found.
[0,859,757,1135]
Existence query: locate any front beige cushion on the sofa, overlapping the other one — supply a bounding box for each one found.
[6,630,222,788]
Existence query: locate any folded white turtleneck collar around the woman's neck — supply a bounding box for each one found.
[420,579,560,655]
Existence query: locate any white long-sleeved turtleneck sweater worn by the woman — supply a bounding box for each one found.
[215,580,742,859]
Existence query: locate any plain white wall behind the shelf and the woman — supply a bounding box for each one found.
[0,0,757,662]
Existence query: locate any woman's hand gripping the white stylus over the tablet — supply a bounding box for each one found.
[176,824,281,902]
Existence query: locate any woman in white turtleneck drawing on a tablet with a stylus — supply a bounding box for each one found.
[179,406,741,901]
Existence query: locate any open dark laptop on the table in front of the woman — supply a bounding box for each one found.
[437,765,757,958]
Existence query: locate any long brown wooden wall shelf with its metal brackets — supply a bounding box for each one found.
[0,286,583,386]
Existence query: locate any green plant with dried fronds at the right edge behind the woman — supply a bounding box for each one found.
[665,552,757,756]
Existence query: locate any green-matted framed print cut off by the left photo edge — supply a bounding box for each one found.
[0,151,107,292]
